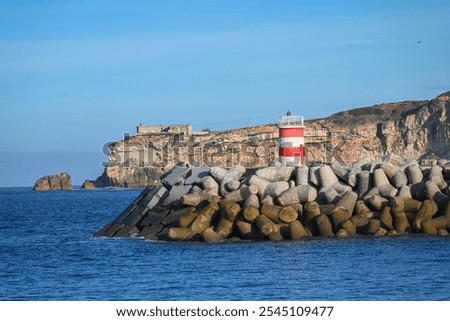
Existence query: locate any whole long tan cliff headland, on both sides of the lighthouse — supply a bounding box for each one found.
[95,92,450,187]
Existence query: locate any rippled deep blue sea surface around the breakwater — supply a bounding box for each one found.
[0,188,450,301]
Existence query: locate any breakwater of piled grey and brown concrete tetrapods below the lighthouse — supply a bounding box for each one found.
[95,158,450,242]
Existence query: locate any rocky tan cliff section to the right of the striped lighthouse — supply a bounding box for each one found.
[307,92,450,163]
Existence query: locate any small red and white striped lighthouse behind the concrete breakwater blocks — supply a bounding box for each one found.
[278,112,306,166]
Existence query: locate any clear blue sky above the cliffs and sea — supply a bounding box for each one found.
[0,0,450,186]
